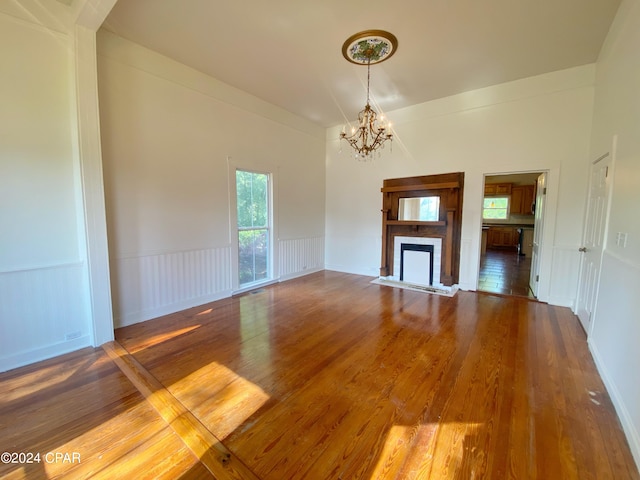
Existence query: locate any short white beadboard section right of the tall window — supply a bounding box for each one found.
[278,237,324,280]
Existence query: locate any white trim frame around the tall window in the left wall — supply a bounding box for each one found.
[227,157,279,295]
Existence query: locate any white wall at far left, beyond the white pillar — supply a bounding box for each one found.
[0,10,93,371]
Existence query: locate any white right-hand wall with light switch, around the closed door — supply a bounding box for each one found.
[589,0,640,466]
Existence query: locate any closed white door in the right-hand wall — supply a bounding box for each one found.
[576,153,611,334]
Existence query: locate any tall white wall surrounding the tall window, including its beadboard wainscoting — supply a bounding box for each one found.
[98,30,325,326]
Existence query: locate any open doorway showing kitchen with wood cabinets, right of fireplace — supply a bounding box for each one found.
[478,172,542,298]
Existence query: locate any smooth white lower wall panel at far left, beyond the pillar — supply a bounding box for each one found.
[0,262,92,371]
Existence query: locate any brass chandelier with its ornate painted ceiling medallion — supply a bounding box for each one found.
[340,30,398,160]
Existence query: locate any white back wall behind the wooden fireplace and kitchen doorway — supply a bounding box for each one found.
[326,65,594,306]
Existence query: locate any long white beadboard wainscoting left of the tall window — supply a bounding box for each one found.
[112,246,231,327]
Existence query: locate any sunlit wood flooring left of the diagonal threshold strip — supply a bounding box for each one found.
[0,349,213,480]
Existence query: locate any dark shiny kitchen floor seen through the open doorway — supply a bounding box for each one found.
[478,249,534,298]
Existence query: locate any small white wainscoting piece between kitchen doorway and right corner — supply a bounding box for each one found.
[549,245,580,309]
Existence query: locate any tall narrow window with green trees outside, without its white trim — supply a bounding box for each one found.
[236,170,271,286]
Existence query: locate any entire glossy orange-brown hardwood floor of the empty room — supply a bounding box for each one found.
[0,272,640,480]
